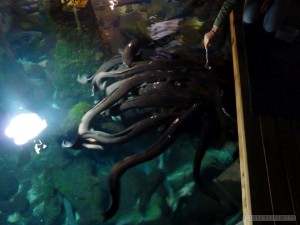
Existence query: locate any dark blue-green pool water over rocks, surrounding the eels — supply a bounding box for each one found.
[0,0,241,225]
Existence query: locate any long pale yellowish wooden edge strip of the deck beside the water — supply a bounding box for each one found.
[230,12,252,225]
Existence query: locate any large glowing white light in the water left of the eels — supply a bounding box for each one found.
[5,113,47,145]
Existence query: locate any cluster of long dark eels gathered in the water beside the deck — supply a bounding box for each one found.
[62,40,237,221]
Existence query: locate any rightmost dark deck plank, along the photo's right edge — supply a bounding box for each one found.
[277,118,300,221]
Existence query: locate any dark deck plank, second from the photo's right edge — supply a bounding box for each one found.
[260,116,295,224]
